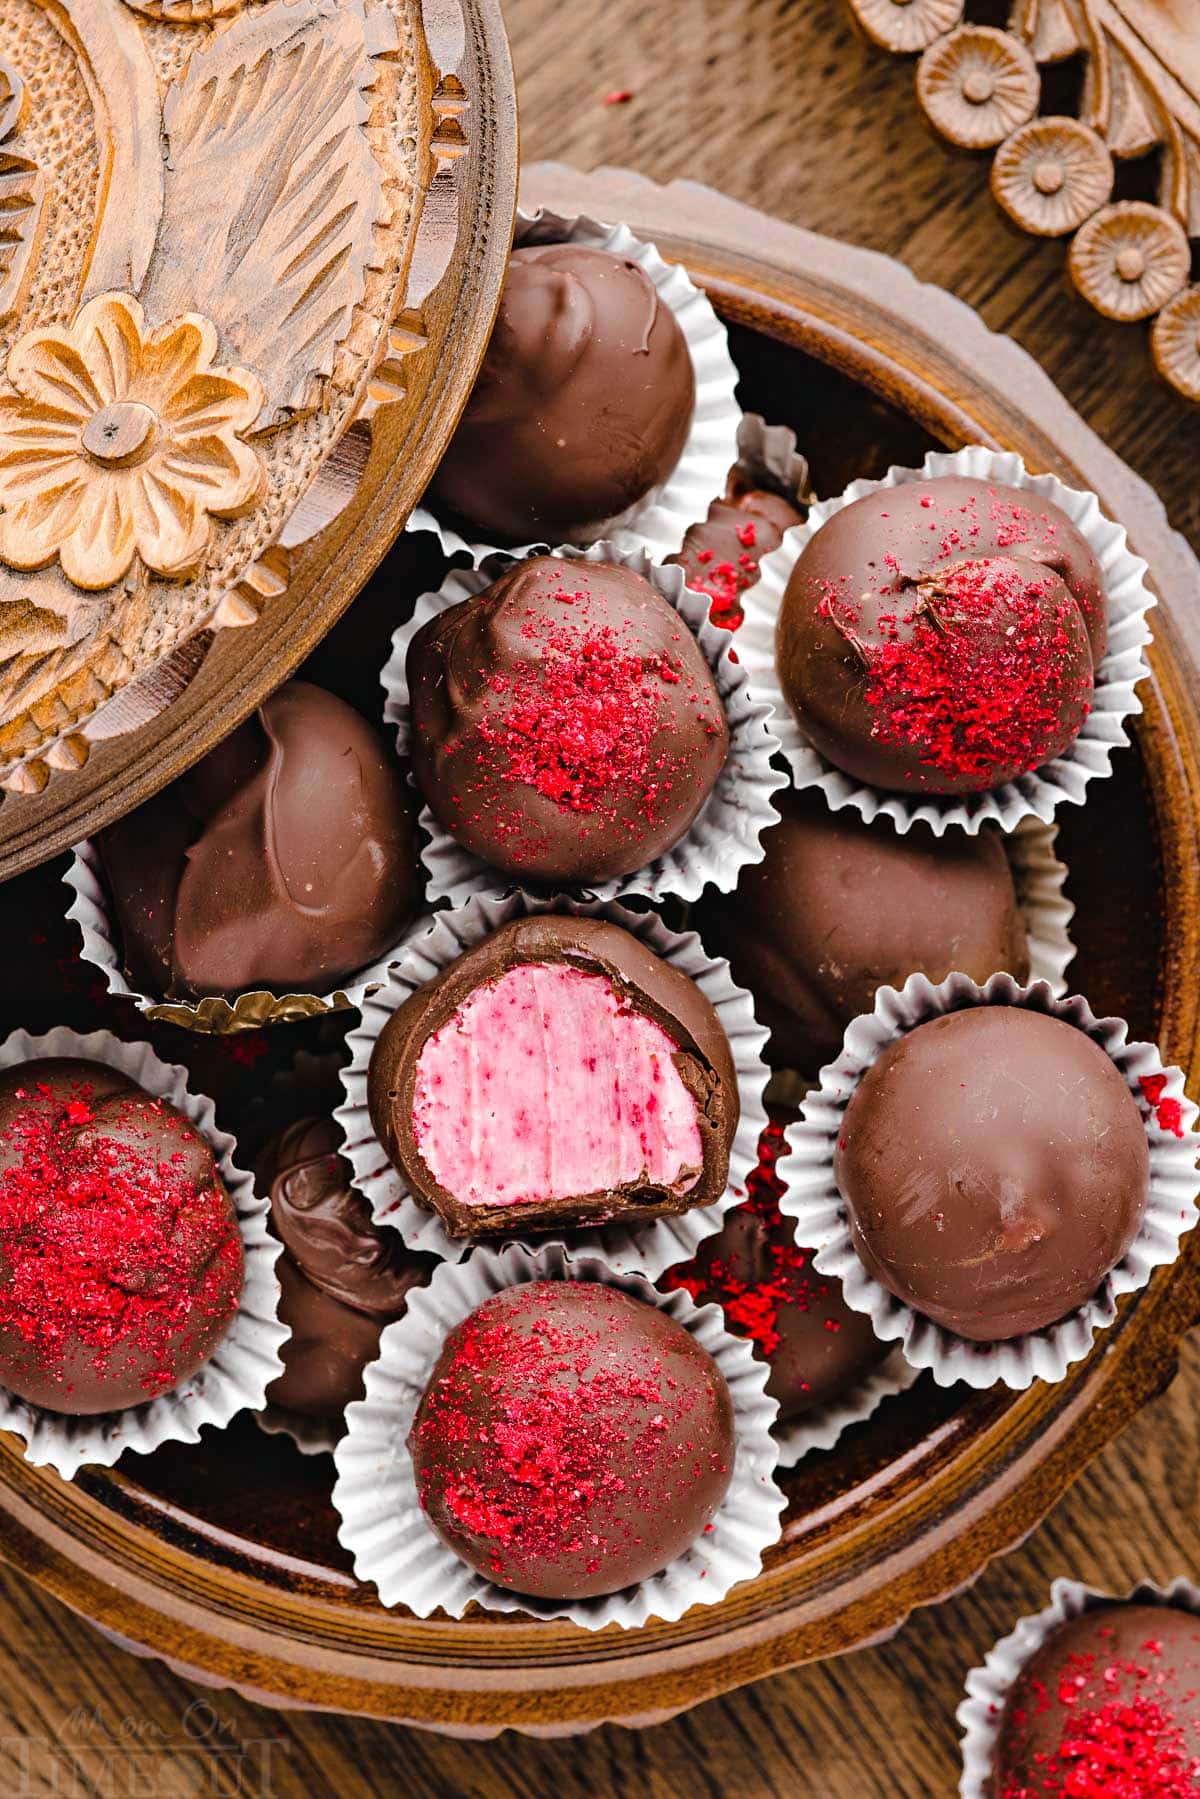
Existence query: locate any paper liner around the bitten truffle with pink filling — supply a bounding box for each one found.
[335,894,766,1281]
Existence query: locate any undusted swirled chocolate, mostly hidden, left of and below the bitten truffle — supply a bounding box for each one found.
[257,1119,435,1421]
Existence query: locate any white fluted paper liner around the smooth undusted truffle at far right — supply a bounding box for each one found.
[779,975,1200,1389]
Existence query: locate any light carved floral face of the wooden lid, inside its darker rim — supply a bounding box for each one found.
[0,0,437,792]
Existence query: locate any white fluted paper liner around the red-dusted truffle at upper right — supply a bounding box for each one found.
[738,444,1157,837]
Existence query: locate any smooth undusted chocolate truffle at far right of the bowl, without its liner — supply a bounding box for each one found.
[833,1006,1150,1342]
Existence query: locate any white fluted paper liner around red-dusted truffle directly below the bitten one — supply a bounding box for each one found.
[333,1243,784,1630]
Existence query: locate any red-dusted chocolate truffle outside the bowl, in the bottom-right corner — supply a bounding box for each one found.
[990,1605,1200,1799]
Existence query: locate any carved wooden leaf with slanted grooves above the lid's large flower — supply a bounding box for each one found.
[142,0,394,426]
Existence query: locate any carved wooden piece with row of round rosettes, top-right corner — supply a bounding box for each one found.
[849,0,1200,399]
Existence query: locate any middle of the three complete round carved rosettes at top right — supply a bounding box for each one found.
[991,119,1114,237]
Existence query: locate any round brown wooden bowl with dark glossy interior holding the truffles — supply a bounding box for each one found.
[0,167,1200,1736]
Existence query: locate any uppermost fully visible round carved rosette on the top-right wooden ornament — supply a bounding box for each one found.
[918,25,1042,149]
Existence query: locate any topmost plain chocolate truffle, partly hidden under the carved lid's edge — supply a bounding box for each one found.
[430,243,696,543]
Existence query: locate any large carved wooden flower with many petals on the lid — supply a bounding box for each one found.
[0,293,264,588]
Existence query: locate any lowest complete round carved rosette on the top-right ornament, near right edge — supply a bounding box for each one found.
[1070,200,1191,320]
